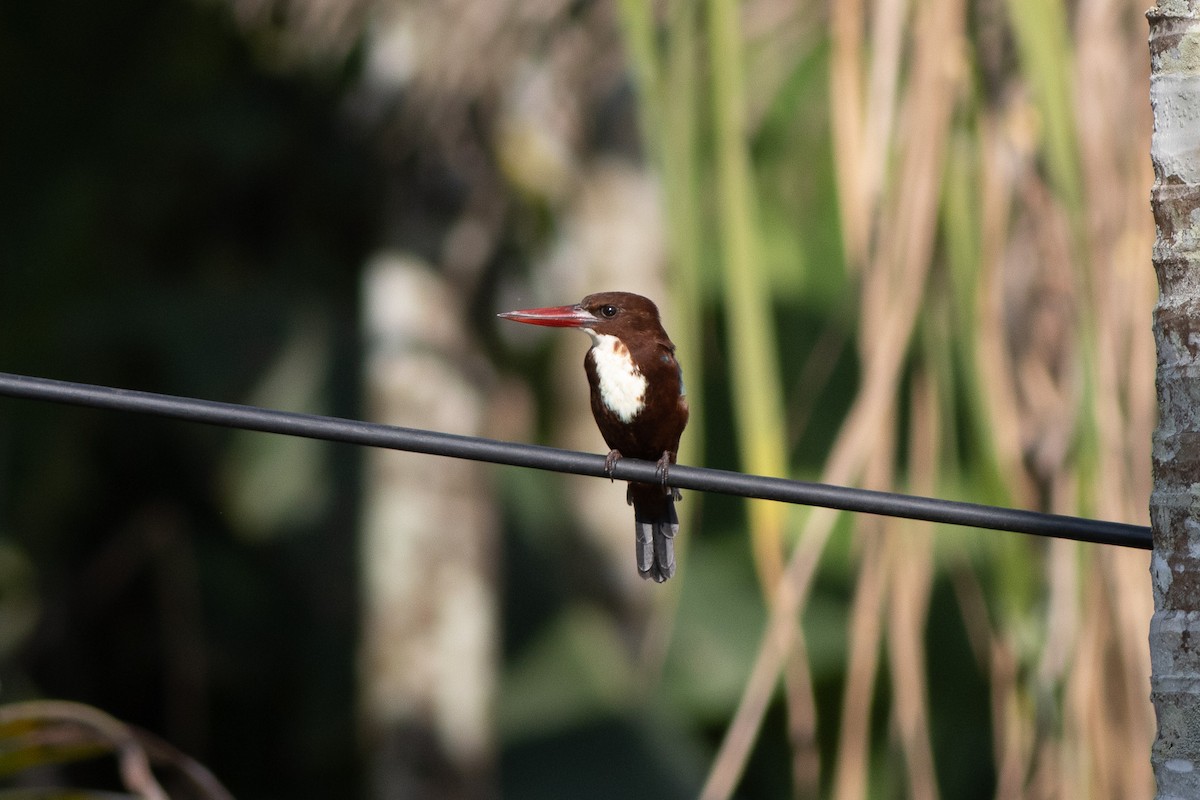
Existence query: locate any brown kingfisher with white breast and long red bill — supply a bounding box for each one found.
[498,291,688,583]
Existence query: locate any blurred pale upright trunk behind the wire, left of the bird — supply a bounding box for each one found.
[360,255,499,800]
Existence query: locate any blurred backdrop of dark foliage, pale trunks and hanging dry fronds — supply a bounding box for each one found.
[0,0,1154,799]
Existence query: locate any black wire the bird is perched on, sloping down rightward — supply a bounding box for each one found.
[0,373,1152,549]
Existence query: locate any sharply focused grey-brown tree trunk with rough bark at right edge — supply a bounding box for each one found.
[1147,0,1200,800]
